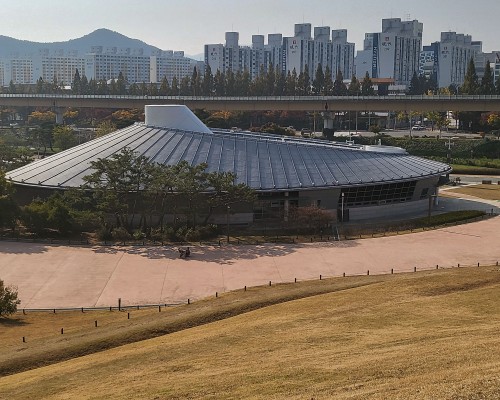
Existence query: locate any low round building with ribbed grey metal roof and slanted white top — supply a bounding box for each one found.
[7,105,451,223]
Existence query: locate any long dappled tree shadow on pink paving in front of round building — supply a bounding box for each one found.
[92,240,358,265]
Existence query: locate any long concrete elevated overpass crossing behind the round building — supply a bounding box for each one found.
[0,94,500,112]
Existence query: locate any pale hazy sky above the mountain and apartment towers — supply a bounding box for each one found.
[0,0,500,55]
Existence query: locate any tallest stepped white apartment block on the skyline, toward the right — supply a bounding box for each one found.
[356,18,423,85]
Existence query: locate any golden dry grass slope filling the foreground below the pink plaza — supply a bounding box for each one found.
[0,267,500,400]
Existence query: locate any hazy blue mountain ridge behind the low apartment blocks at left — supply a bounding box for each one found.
[0,29,164,57]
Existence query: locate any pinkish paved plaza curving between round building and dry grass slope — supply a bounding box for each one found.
[0,217,500,308]
